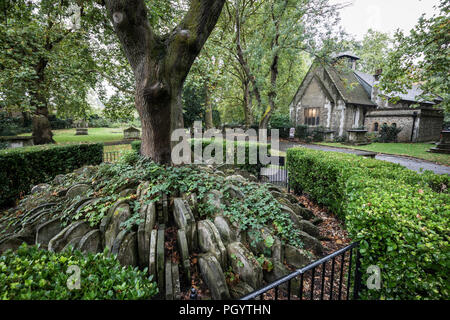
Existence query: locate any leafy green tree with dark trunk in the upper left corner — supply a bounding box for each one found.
[0,0,97,144]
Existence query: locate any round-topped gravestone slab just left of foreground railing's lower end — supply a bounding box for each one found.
[198,253,230,300]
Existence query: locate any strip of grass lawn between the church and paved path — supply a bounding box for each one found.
[317,142,450,165]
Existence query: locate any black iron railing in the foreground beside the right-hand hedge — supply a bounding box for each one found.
[241,242,361,300]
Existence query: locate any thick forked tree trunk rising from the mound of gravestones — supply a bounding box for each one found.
[106,0,225,163]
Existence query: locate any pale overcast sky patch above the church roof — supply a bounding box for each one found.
[332,0,439,40]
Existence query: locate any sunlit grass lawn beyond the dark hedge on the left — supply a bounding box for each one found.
[22,128,123,144]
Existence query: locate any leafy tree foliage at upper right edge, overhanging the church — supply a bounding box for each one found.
[380,0,450,114]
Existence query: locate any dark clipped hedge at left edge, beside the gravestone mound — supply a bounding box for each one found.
[0,143,103,206]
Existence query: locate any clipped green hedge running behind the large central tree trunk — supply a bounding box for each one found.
[131,139,271,175]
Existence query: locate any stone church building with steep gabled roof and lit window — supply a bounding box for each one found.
[289,52,444,142]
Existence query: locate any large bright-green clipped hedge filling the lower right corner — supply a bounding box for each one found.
[287,149,450,299]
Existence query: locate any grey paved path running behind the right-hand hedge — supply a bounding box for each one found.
[280,141,450,174]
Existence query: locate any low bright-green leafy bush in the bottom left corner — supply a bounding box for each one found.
[0,244,158,300]
